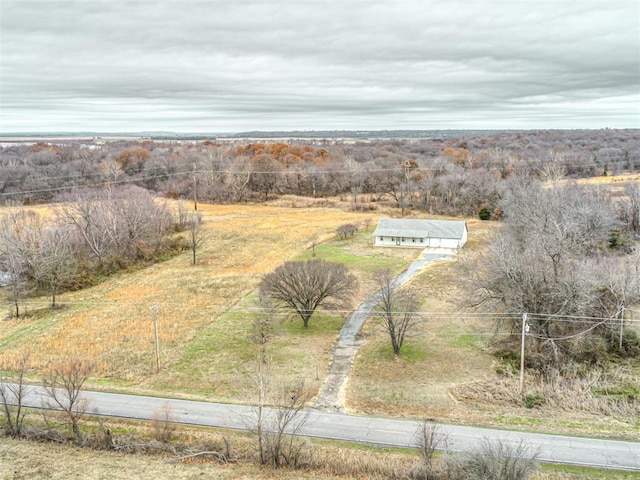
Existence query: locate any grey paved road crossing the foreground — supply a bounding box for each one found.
[11,387,640,471]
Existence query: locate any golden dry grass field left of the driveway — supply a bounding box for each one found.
[0,199,416,401]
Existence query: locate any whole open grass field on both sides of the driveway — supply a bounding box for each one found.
[0,200,640,439]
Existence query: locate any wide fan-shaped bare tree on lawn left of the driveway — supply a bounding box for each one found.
[260,259,357,328]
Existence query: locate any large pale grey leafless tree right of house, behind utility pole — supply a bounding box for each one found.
[466,178,635,367]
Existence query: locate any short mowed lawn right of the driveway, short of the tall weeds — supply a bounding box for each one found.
[347,220,497,420]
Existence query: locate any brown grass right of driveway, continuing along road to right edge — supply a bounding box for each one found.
[347,221,640,439]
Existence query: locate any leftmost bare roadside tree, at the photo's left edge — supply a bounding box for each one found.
[0,353,29,437]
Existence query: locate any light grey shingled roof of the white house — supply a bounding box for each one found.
[373,218,467,239]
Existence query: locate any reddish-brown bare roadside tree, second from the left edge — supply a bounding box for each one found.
[43,357,94,443]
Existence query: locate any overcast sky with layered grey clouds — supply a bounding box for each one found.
[0,0,640,134]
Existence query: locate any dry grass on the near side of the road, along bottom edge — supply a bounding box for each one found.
[0,438,638,480]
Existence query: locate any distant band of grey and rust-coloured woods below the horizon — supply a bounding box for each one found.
[0,130,640,216]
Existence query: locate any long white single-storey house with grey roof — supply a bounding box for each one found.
[373,218,467,249]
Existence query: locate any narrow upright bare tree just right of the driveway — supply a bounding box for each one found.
[374,270,419,356]
